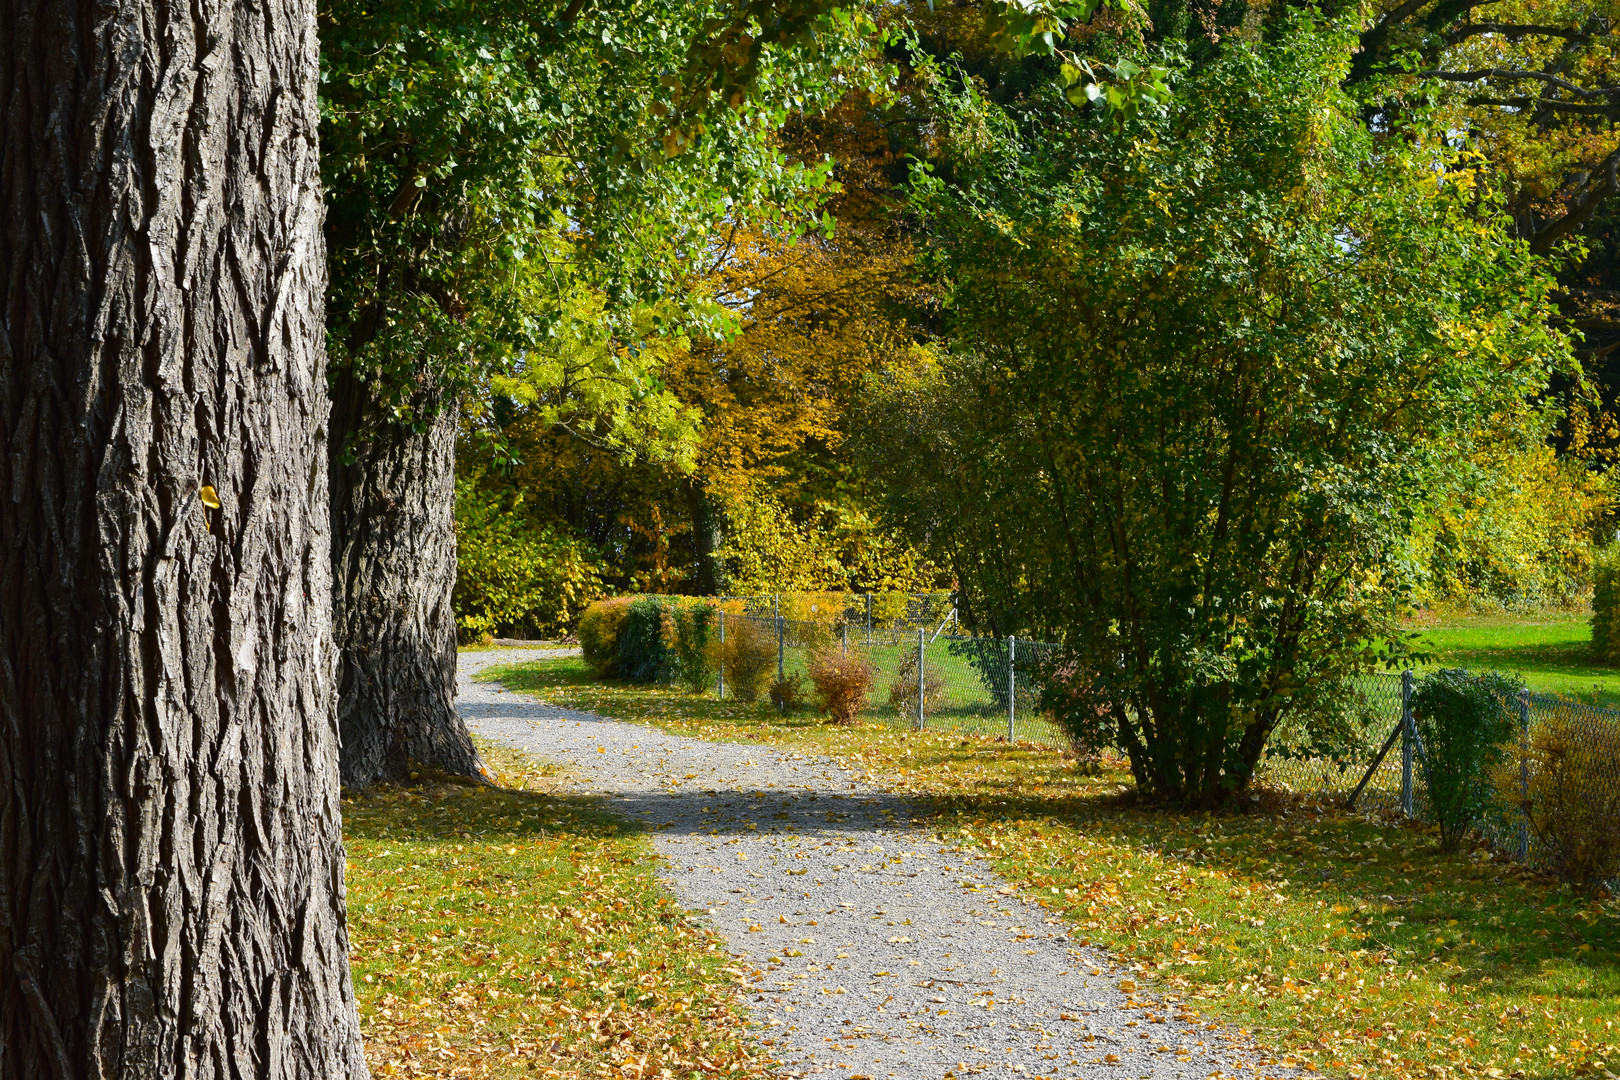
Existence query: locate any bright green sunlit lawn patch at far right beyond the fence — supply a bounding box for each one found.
[1419,614,1620,709]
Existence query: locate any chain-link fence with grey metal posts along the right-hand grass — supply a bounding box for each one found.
[703,612,1620,878]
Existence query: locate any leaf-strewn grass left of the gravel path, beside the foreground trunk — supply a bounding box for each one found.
[343,746,768,1078]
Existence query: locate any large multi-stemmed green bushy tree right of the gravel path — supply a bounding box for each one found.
[867,23,1568,805]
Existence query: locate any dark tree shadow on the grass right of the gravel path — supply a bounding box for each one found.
[957,780,1620,1002]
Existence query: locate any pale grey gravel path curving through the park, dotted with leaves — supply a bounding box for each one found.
[458,649,1298,1080]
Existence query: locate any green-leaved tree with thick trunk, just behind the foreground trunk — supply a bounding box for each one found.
[322,0,862,785]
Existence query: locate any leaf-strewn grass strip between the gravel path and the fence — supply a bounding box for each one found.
[479,661,1620,1078]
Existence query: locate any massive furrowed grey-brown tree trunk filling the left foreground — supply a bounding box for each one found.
[0,0,366,1080]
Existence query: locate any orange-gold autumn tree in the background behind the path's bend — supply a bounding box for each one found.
[467,89,932,593]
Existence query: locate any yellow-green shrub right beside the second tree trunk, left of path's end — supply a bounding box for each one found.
[450,481,603,641]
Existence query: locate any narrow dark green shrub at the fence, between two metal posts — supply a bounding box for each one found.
[1413,667,1523,850]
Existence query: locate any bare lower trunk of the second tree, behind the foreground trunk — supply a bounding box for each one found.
[332,371,486,787]
